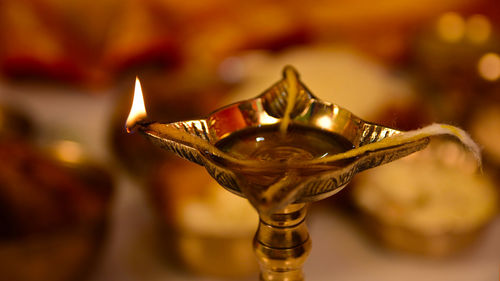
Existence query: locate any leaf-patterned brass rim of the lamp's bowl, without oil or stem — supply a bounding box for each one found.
[141,66,428,210]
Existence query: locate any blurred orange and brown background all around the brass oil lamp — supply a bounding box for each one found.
[0,0,500,281]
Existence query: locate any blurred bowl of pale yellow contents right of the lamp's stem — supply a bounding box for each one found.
[353,140,498,256]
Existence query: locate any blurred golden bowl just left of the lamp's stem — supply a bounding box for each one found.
[150,159,258,278]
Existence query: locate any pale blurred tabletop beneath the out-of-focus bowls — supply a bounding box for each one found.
[0,85,500,281]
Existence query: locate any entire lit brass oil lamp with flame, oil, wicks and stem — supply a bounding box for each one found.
[126,66,479,281]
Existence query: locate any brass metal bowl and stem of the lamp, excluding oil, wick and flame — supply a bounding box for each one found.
[135,66,429,281]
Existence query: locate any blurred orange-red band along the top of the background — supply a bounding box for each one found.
[0,0,486,87]
